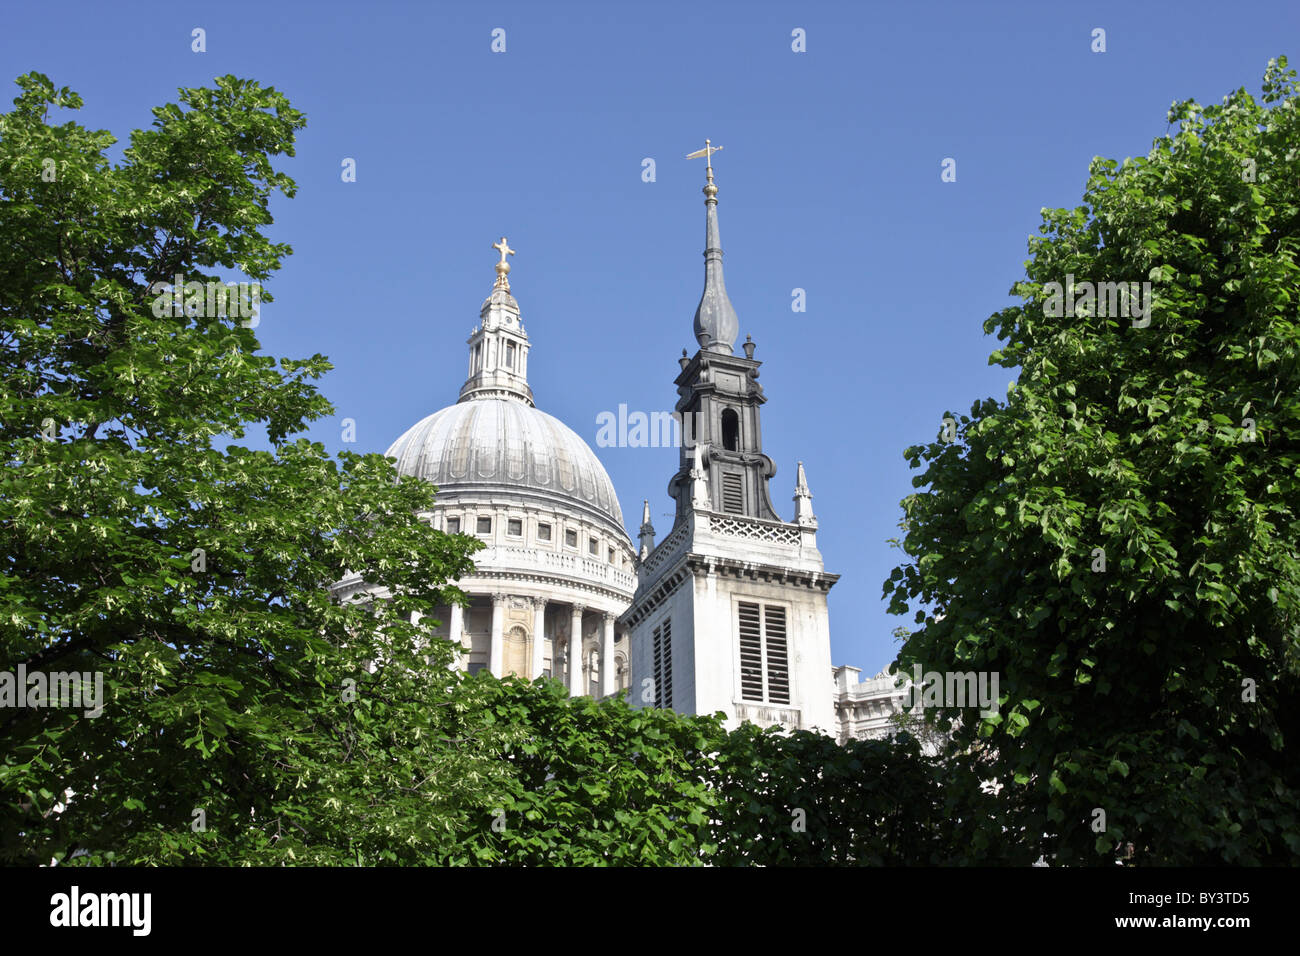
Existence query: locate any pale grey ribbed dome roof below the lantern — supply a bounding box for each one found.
[385,398,627,537]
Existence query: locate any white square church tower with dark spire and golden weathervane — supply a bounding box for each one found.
[620,147,839,735]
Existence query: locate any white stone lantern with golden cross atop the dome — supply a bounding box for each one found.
[459,235,533,405]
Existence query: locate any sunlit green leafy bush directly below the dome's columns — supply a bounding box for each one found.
[439,674,727,866]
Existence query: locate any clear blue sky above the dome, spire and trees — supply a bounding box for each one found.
[0,0,1300,672]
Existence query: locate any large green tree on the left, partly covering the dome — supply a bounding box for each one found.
[0,73,491,864]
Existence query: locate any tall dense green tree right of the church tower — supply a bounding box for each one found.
[885,57,1300,864]
